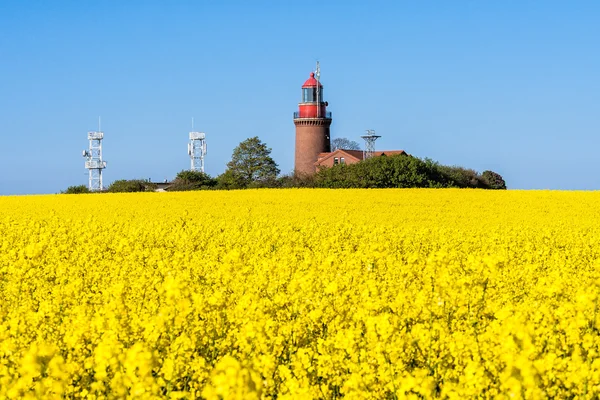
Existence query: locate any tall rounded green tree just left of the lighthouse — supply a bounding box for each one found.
[224,136,279,187]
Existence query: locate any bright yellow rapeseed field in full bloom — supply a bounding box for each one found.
[0,189,600,399]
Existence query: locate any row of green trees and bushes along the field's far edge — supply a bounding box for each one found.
[63,136,506,193]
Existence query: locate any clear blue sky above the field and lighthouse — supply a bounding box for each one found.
[0,0,600,194]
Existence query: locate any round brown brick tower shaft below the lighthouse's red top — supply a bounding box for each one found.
[294,118,331,175]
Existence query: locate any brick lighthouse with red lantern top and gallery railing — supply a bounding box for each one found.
[294,63,331,175]
